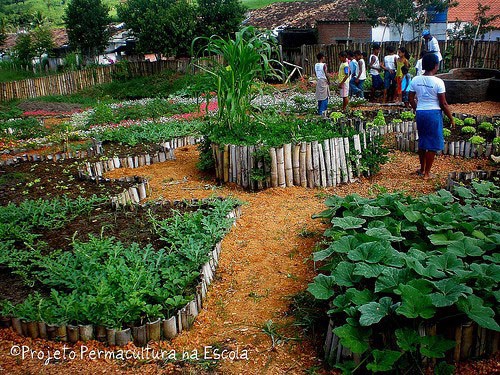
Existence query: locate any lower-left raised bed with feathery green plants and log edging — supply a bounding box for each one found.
[0,199,240,346]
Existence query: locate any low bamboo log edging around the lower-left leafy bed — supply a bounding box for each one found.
[0,197,241,346]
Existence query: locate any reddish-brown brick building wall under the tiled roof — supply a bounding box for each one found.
[317,22,372,44]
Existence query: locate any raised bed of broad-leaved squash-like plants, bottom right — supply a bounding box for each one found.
[308,182,500,373]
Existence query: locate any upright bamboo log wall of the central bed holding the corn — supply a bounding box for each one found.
[212,135,366,190]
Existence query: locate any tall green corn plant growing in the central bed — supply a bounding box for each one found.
[193,27,281,129]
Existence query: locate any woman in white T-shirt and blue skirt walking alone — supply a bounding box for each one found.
[408,53,455,180]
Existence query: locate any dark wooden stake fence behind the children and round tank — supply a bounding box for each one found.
[298,40,500,76]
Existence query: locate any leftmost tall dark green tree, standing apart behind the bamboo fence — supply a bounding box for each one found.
[64,0,110,60]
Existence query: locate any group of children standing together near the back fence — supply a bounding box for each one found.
[315,44,424,115]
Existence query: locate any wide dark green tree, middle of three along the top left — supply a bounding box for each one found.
[117,0,196,58]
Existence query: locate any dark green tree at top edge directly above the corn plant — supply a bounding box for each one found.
[198,0,247,37]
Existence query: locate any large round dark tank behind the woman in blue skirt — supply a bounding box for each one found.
[436,68,500,104]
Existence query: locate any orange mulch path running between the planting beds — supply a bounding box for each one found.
[0,146,491,374]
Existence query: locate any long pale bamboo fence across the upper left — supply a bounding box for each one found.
[0,59,194,101]
